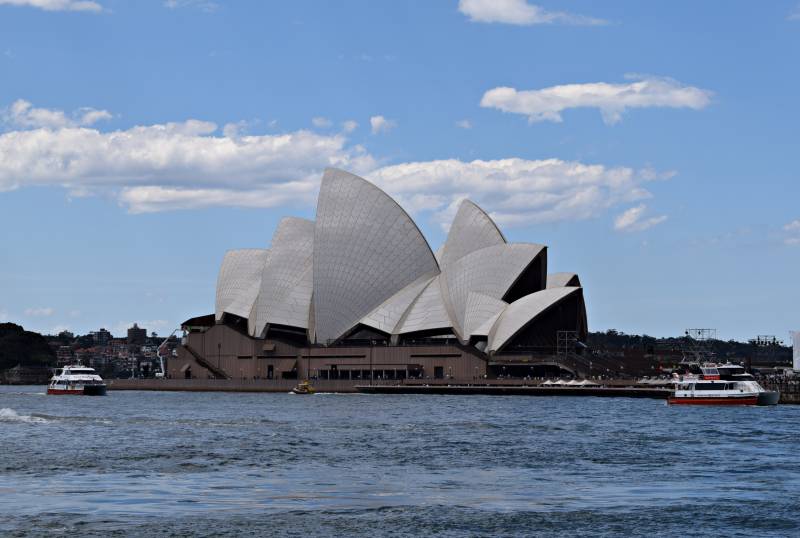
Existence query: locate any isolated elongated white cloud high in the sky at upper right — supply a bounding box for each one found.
[481,77,712,124]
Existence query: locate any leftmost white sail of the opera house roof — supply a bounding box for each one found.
[214,248,269,320]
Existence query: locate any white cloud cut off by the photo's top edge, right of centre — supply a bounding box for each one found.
[458,0,607,26]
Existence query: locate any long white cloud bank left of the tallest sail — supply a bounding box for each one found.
[0,98,374,213]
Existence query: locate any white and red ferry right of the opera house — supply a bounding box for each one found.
[667,363,780,405]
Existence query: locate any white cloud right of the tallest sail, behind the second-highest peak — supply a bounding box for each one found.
[368,159,667,228]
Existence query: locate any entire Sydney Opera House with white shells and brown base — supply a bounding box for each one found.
[169,169,587,383]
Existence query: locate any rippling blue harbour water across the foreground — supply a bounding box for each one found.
[0,387,800,536]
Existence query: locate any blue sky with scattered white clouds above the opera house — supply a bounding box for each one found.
[0,0,800,339]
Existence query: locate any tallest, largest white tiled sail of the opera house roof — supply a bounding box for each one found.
[313,169,439,343]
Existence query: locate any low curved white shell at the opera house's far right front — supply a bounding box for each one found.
[486,287,581,353]
